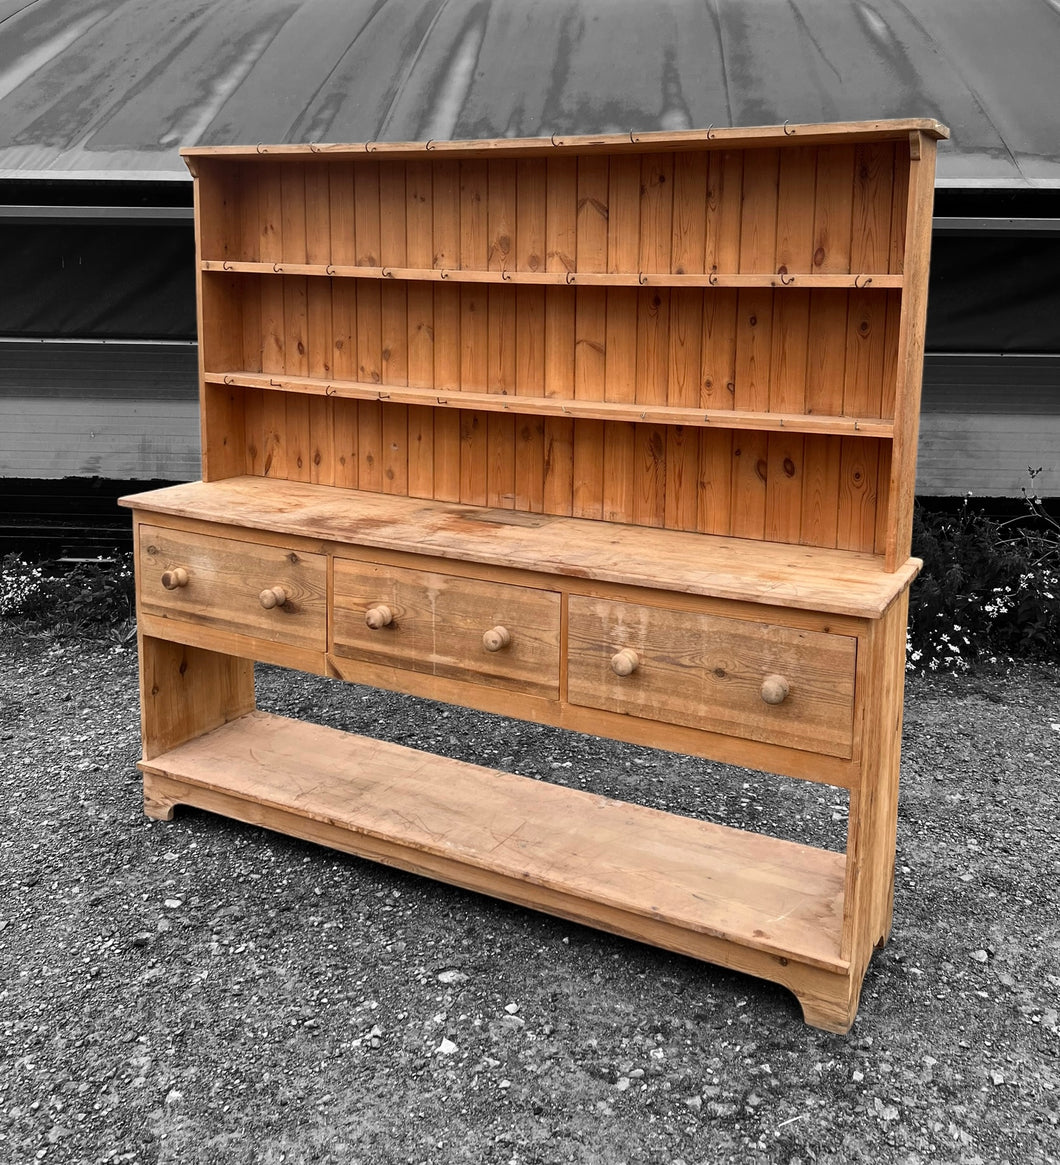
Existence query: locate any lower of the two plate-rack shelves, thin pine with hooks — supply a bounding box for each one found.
[204,370,895,438]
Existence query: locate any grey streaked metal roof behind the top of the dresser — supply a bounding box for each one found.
[0,0,1060,186]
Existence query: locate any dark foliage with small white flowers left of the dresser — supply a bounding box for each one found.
[0,553,136,643]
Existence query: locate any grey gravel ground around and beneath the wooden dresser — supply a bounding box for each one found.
[0,624,1060,1165]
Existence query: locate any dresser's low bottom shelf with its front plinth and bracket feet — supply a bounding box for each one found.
[140,712,860,1031]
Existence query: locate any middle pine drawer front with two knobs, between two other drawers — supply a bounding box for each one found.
[332,558,559,699]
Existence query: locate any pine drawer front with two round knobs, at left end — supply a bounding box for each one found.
[137,525,327,651]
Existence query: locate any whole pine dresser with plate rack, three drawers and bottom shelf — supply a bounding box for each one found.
[125,120,946,1031]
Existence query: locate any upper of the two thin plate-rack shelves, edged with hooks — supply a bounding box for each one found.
[202,259,903,290]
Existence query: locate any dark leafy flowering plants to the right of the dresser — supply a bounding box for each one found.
[907,472,1060,671]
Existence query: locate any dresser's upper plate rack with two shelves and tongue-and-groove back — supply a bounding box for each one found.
[193,129,934,566]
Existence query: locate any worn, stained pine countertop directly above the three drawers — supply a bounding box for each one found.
[121,476,920,619]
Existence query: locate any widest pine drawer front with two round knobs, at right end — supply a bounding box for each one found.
[567,595,857,757]
